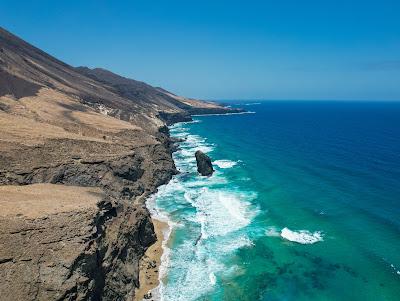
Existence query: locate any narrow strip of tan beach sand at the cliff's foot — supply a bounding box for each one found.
[134,218,168,301]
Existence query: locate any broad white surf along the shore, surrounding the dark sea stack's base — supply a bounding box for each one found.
[147,124,258,301]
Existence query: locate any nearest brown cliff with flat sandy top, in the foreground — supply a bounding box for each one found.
[0,184,148,300]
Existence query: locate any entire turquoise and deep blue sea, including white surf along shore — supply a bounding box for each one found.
[148,102,400,301]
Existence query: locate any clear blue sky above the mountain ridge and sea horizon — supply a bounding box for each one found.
[0,0,400,100]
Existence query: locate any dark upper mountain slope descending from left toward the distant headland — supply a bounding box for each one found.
[0,28,239,126]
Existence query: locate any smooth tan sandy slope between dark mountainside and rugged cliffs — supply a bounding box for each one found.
[0,88,142,145]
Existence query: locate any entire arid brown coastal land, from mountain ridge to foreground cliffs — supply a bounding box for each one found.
[0,28,241,300]
